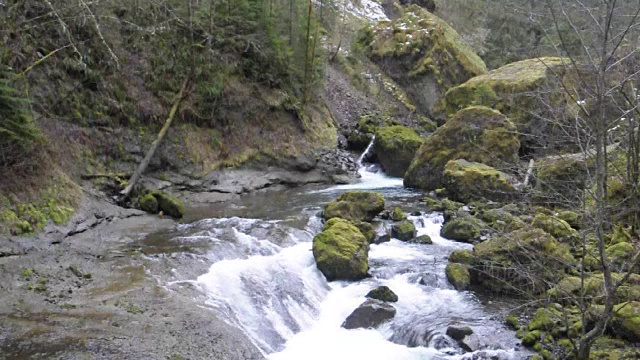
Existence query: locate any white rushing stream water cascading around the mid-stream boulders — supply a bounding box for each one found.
[159,141,526,360]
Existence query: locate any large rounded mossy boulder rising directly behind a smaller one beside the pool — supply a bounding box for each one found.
[404,106,520,190]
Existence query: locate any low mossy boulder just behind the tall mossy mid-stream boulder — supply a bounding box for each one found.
[324,191,384,222]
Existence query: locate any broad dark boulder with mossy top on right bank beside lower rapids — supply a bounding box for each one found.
[473,227,575,294]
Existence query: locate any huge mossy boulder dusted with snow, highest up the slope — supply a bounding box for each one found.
[358,5,487,117]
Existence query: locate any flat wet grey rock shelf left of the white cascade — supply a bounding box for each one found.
[0,192,263,359]
